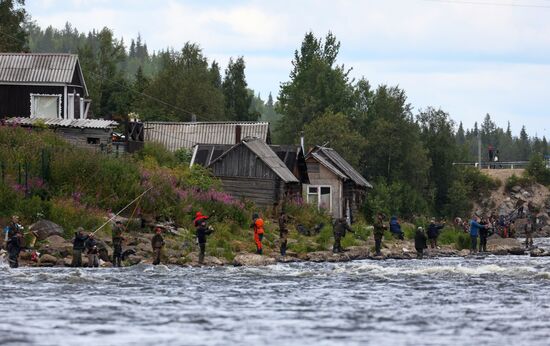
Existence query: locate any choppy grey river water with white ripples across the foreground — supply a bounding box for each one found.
[0,250,550,345]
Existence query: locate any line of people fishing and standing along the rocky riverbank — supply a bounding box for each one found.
[4,207,537,268]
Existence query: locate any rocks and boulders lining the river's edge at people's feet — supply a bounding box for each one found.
[0,234,536,267]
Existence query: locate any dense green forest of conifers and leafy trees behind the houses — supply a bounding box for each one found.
[0,0,549,217]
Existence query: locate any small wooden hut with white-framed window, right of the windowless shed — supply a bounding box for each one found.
[303,146,372,222]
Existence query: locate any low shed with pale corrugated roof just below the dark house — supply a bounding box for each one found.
[4,118,118,150]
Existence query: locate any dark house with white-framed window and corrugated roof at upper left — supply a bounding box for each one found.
[0,53,91,119]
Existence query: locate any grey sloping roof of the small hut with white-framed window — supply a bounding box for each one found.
[308,147,372,188]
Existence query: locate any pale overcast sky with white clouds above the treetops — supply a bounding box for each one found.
[26,0,550,137]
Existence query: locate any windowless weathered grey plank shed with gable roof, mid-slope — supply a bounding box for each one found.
[207,138,301,208]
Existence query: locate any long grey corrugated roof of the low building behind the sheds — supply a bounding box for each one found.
[144,121,271,151]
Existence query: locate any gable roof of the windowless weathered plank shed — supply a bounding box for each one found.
[207,138,299,183]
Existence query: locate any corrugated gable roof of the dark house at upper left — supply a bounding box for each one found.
[0,53,88,95]
